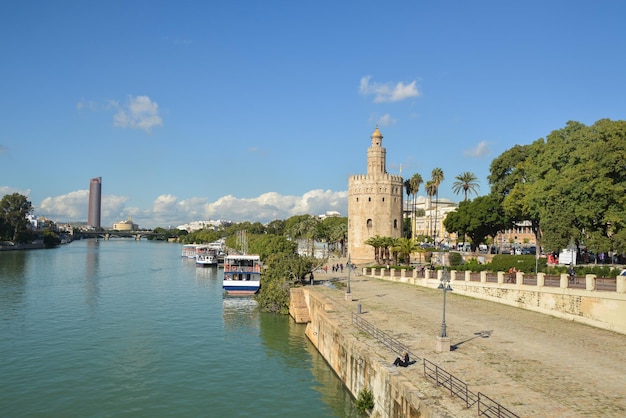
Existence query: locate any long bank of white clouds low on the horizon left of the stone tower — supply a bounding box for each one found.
[35,190,348,228]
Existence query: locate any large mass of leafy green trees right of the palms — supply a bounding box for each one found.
[444,119,626,254]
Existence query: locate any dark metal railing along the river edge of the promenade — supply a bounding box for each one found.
[352,312,519,418]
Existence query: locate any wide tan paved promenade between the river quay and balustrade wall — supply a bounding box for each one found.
[315,260,626,417]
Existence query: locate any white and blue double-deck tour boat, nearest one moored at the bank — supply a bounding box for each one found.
[222,254,261,295]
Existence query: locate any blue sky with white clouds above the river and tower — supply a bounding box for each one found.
[0,0,626,228]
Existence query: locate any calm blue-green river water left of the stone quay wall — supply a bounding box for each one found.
[0,239,358,417]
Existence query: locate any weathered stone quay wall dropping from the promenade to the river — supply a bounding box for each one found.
[290,287,458,418]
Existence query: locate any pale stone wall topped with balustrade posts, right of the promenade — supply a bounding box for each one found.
[363,268,626,334]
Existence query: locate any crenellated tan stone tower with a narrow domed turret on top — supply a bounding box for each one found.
[348,127,404,264]
